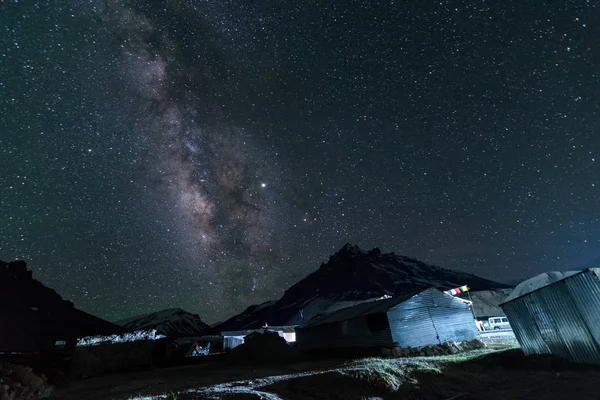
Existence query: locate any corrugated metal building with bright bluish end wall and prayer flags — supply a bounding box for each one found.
[296,288,477,350]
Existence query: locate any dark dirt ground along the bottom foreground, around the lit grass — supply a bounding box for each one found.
[50,349,600,400]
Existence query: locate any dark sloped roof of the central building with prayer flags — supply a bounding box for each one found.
[303,288,431,328]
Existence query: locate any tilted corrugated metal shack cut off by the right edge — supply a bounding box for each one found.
[501,268,600,364]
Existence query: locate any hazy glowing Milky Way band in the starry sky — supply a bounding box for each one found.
[105,0,290,305]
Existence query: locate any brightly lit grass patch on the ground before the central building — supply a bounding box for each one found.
[349,357,442,391]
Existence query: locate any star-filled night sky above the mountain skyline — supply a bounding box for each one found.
[0,0,600,322]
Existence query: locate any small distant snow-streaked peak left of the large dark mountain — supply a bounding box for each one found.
[116,308,210,337]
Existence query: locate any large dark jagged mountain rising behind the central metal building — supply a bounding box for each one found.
[213,244,510,332]
